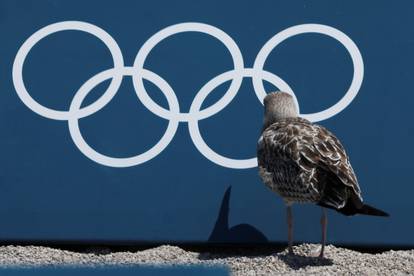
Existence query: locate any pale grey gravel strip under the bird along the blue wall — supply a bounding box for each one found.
[0,244,414,275]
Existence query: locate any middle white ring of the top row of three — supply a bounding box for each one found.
[132,23,244,122]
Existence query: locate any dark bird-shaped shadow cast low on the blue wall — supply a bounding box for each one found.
[208,186,268,243]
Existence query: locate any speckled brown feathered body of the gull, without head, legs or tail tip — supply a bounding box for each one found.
[257,117,385,215]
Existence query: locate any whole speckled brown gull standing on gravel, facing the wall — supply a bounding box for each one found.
[257,91,389,258]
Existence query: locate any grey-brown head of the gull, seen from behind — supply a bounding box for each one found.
[263,91,299,126]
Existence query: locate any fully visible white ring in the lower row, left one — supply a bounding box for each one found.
[68,67,179,167]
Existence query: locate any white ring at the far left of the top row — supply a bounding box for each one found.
[13,21,124,120]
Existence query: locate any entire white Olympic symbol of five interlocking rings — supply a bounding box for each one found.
[13,21,364,169]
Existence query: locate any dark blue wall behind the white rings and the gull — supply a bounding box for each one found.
[0,0,414,245]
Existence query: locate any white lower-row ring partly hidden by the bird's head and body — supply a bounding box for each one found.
[188,68,299,169]
